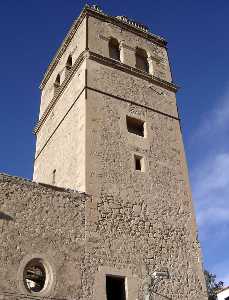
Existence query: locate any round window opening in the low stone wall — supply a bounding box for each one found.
[23,258,47,293]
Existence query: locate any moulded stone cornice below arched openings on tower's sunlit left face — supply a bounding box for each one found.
[33,50,87,134]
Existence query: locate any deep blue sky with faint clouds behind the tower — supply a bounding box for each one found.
[0,0,229,284]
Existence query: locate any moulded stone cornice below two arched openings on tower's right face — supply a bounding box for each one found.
[88,51,179,93]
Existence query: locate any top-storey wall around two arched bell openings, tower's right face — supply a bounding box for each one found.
[88,17,171,81]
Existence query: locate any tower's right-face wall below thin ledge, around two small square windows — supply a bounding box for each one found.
[86,91,207,300]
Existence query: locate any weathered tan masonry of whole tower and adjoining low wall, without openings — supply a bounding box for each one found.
[0,4,207,300]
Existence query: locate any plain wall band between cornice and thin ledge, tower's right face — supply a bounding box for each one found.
[87,60,178,117]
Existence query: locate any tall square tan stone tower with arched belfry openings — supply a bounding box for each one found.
[22,6,207,300]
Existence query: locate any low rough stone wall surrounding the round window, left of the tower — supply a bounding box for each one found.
[0,174,89,300]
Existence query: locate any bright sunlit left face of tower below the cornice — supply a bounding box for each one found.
[33,63,86,191]
